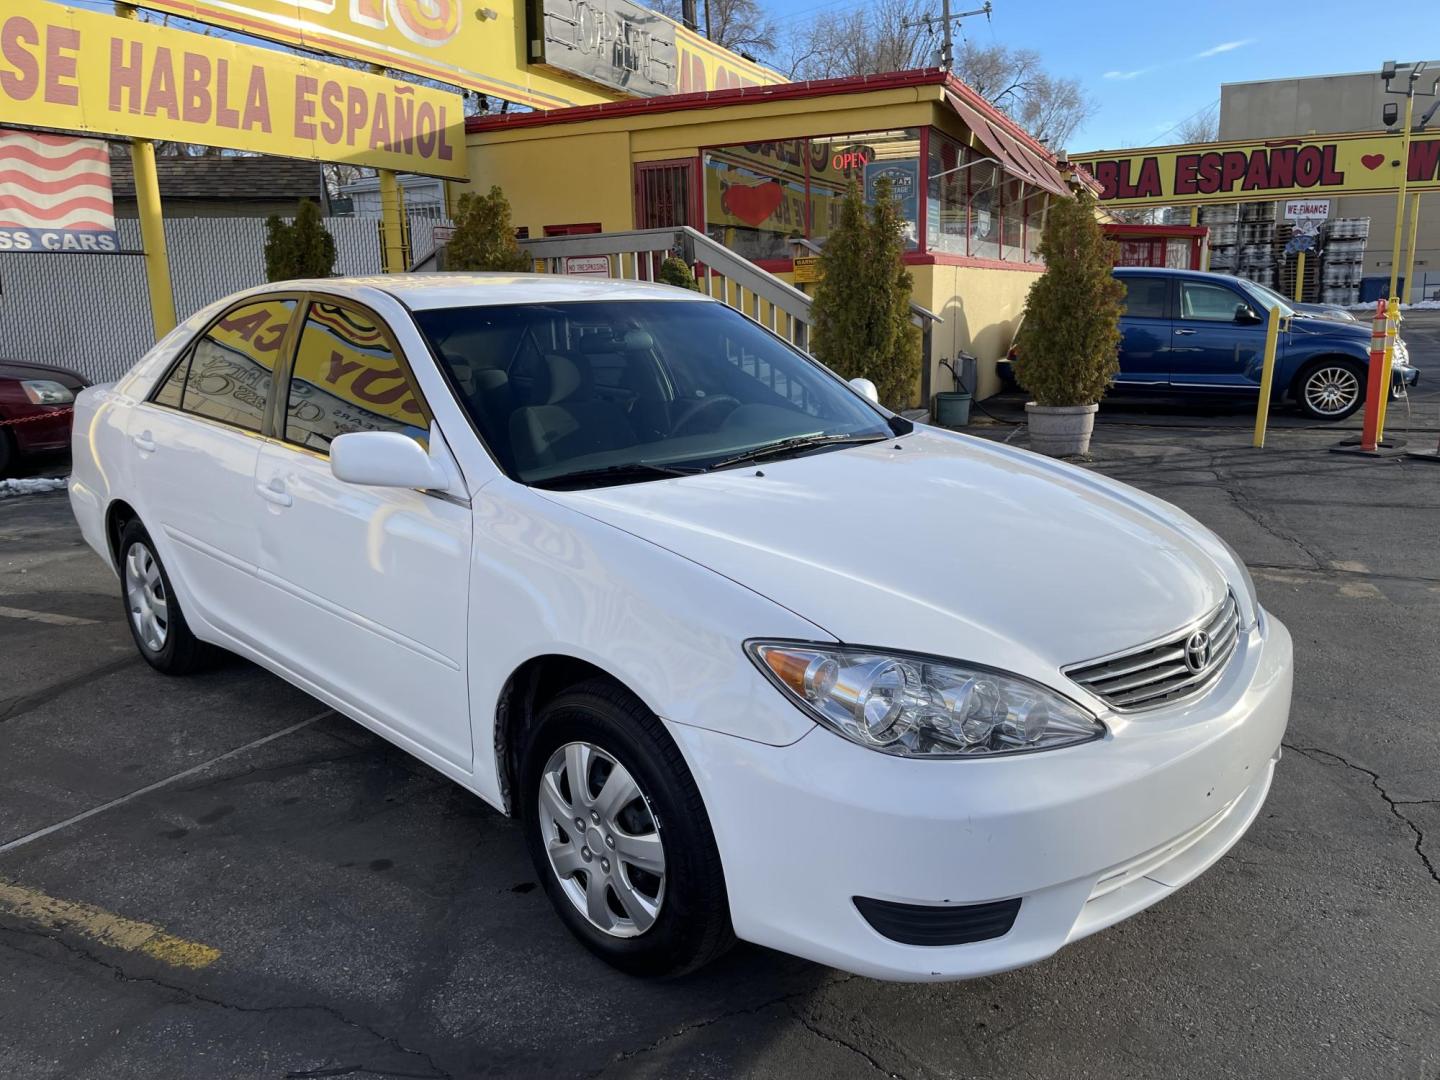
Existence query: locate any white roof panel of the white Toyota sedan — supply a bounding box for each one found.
[260,272,707,311]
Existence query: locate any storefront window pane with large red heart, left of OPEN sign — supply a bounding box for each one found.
[706,138,806,261]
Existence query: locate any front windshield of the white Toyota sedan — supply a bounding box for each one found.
[415,300,892,487]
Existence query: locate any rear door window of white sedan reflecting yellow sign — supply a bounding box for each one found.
[151,300,295,432]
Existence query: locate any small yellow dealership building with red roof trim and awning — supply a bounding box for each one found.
[451,69,1089,405]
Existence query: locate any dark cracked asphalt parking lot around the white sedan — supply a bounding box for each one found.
[0,312,1440,1080]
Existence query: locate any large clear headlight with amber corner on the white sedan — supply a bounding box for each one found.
[744,641,1104,757]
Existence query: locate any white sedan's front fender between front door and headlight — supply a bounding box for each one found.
[468,480,834,805]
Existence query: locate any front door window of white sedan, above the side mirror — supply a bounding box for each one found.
[285,302,431,454]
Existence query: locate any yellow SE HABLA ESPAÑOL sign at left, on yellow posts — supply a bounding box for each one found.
[0,0,467,179]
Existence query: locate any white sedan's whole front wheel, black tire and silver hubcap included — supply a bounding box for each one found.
[520,680,734,975]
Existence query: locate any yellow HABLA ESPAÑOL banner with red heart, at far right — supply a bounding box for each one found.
[1074,132,1440,206]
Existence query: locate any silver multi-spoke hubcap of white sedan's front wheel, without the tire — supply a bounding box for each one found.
[537,743,665,937]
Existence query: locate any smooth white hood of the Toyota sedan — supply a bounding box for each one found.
[544,428,1228,681]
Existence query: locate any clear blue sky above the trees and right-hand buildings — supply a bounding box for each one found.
[762,0,1440,151]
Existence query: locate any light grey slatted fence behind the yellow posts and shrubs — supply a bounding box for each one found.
[0,215,448,382]
